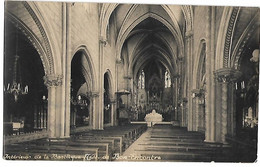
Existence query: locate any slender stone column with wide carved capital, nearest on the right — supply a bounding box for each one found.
[215,68,239,144]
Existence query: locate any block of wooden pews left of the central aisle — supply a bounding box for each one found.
[4,125,147,161]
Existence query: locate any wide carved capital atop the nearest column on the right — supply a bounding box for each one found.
[214,68,242,83]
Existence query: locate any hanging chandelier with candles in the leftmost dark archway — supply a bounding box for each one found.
[4,24,29,102]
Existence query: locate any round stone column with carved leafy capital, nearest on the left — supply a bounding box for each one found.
[43,74,63,138]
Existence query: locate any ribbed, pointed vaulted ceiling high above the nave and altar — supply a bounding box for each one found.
[109,4,185,78]
